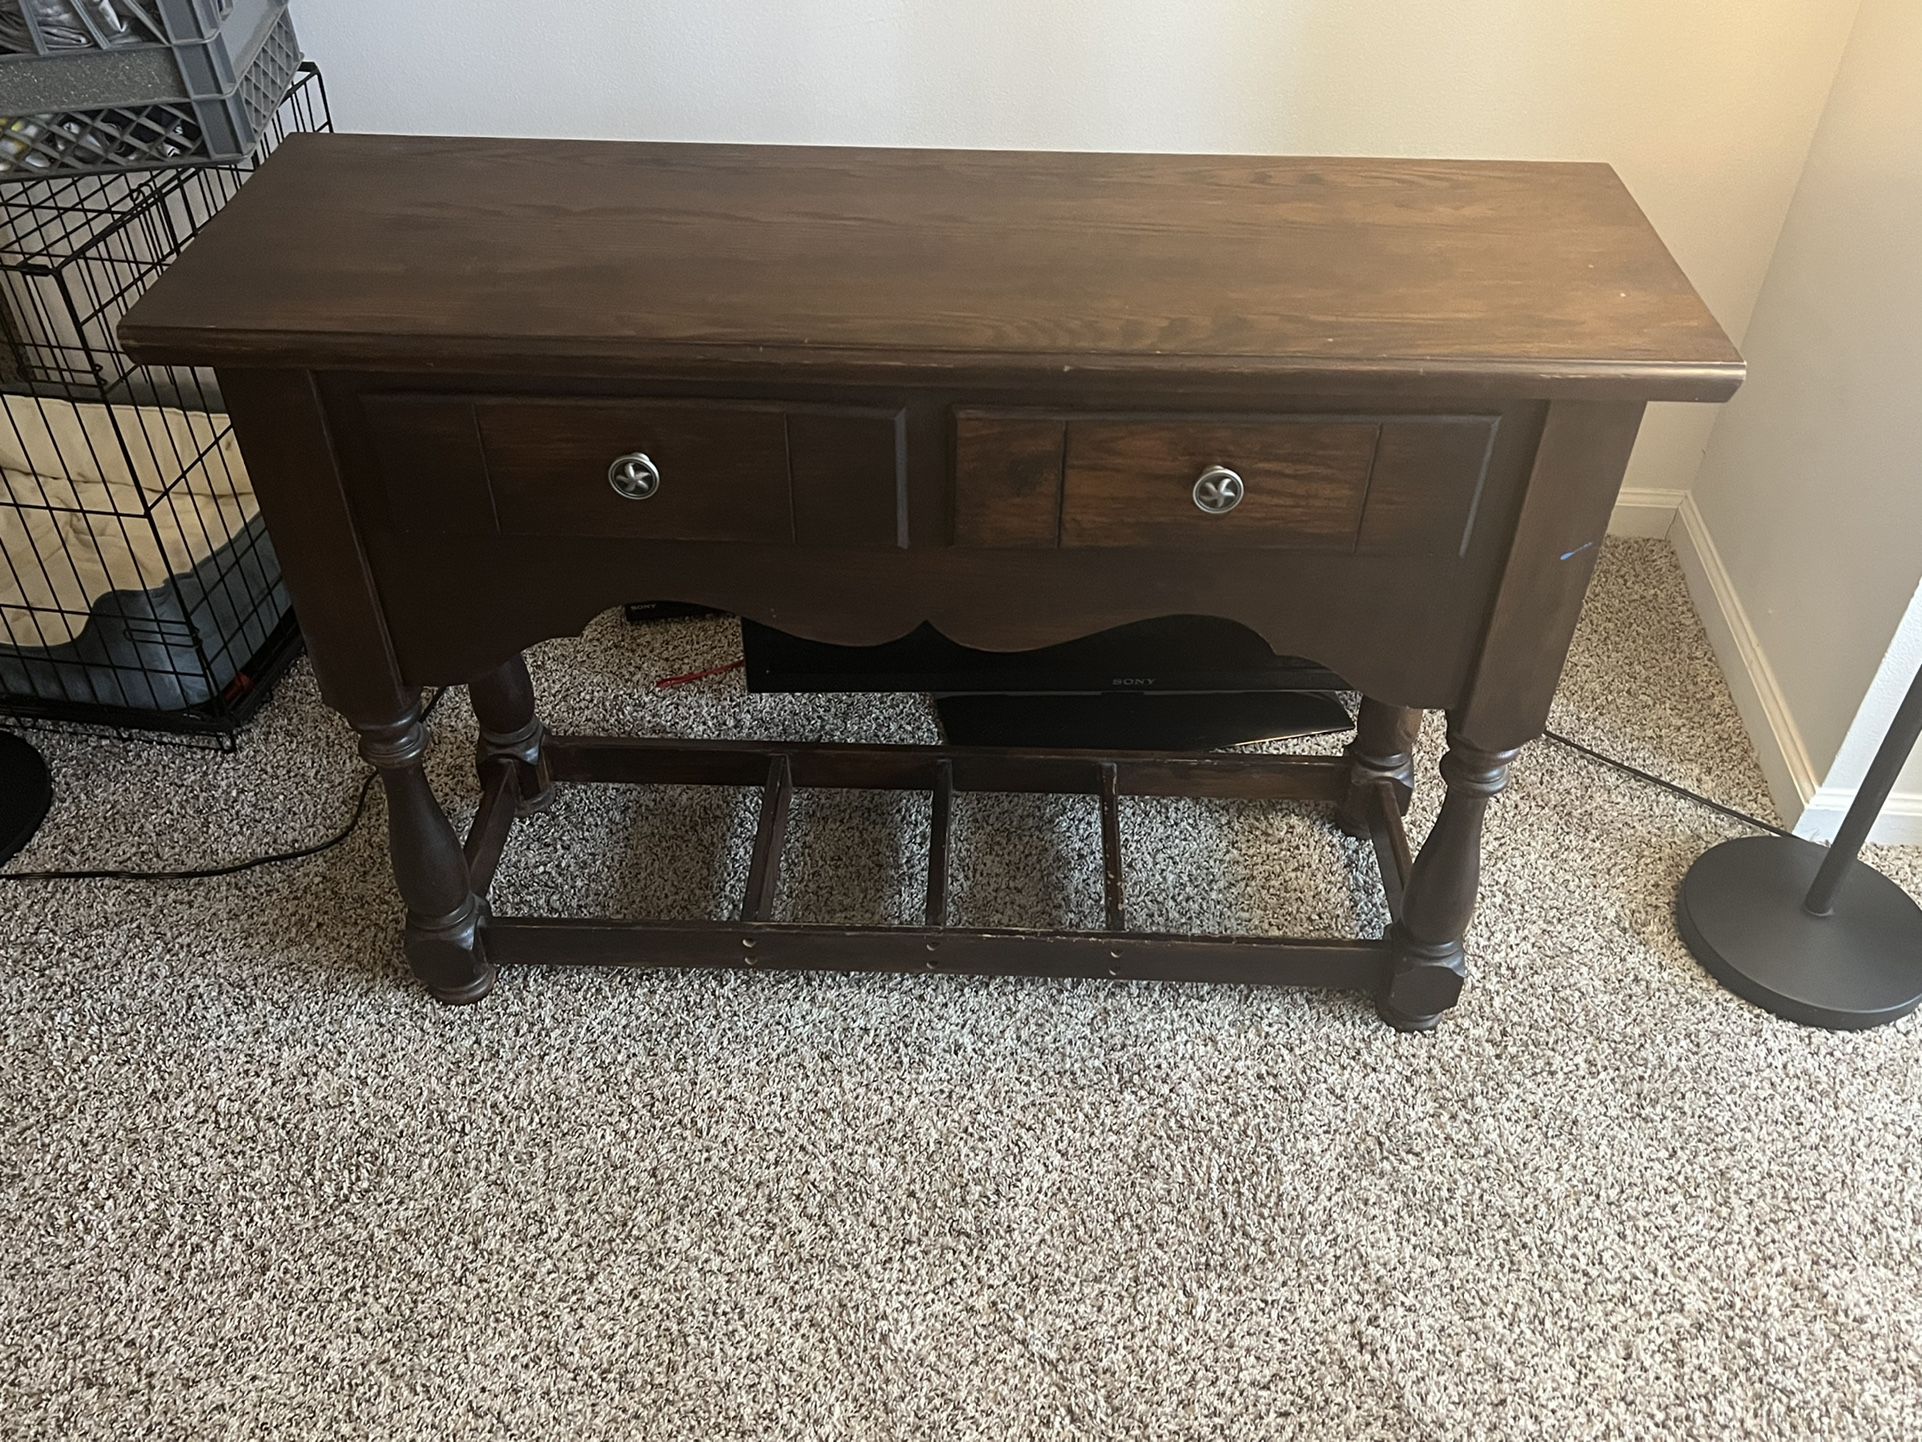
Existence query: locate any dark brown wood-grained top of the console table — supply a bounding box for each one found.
[121,135,1741,400]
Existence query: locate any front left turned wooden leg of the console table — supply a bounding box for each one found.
[359,704,494,1004]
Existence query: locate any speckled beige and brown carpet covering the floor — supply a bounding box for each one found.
[0,542,1922,1442]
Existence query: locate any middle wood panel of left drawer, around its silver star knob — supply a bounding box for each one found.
[475,400,794,542]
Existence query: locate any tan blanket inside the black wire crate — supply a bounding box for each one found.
[0,396,259,646]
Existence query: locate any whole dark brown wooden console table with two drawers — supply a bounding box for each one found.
[119,135,1743,1029]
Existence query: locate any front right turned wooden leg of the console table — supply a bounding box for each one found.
[1376,729,1518,1031]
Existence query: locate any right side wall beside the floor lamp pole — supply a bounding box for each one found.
[1678,0,1922,840]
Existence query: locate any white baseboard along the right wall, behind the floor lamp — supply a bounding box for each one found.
[1668,496,1922,844]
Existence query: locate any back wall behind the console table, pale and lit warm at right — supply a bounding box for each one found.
[298,0,1857,492]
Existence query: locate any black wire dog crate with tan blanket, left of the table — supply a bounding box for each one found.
[0,65,333,748]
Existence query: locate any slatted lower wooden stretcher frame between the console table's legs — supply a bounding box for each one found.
[453,736,1409,990]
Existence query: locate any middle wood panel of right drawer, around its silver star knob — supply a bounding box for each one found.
[1061,419,1380,550]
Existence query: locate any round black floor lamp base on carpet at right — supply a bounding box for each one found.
[1676,836,1922,1031]
